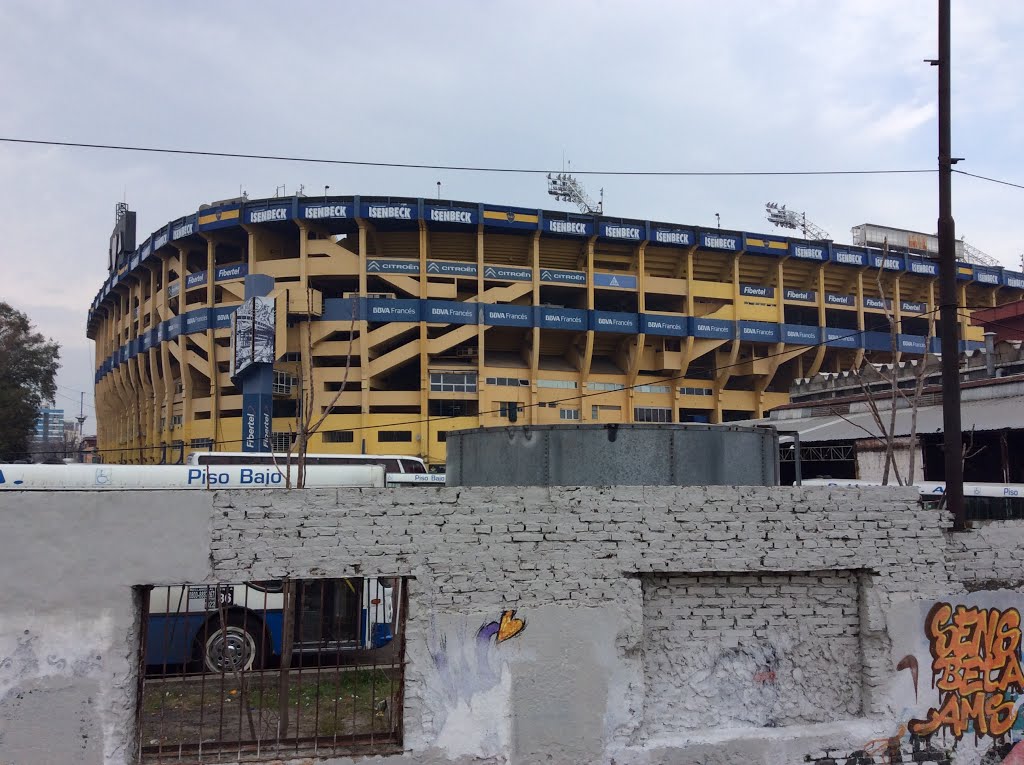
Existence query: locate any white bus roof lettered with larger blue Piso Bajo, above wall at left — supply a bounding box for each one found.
[0,464,386,492]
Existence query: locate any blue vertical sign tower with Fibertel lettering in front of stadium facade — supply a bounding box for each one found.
[231,273,275,452]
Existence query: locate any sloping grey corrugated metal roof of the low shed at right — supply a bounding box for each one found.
[749,396,1024,443]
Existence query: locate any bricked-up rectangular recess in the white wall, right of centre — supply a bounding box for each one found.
[643,570,861,735]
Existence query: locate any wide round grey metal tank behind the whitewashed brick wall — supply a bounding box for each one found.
[446,424,778,486]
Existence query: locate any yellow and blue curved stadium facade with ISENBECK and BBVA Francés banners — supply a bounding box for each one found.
[87,197,1024,465]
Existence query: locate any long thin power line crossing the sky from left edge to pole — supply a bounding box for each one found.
[0,137,936,177]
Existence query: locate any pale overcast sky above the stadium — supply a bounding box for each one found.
[0,0,1024,432]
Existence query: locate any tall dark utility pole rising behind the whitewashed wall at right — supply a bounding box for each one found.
[929,0,967,532]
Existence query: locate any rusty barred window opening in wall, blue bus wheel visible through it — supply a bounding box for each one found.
[136,577,407,763]
